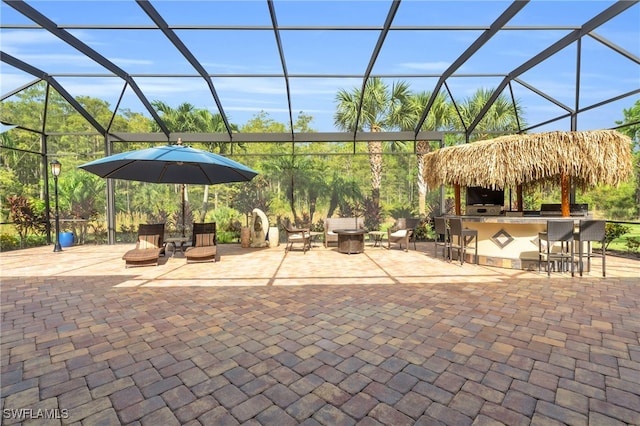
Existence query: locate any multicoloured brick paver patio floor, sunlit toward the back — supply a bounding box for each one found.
[0,243,640,426]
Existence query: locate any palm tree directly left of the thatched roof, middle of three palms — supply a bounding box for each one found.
[403,92,452,216]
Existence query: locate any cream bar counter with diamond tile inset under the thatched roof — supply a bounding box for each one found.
[447,216,588,270]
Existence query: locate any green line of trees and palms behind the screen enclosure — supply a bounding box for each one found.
[0,78,640,246]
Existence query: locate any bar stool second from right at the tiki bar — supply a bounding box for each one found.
[538,220,574,277]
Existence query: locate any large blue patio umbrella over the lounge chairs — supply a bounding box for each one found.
[78,140,258,232]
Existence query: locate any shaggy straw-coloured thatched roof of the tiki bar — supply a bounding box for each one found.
[424,130,633,216]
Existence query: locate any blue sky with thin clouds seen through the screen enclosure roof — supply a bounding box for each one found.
[0,0,640,131]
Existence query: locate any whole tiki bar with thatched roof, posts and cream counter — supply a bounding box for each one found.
[424,130,632,269]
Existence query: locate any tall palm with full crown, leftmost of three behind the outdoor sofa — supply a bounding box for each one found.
[334,77,412,213]
